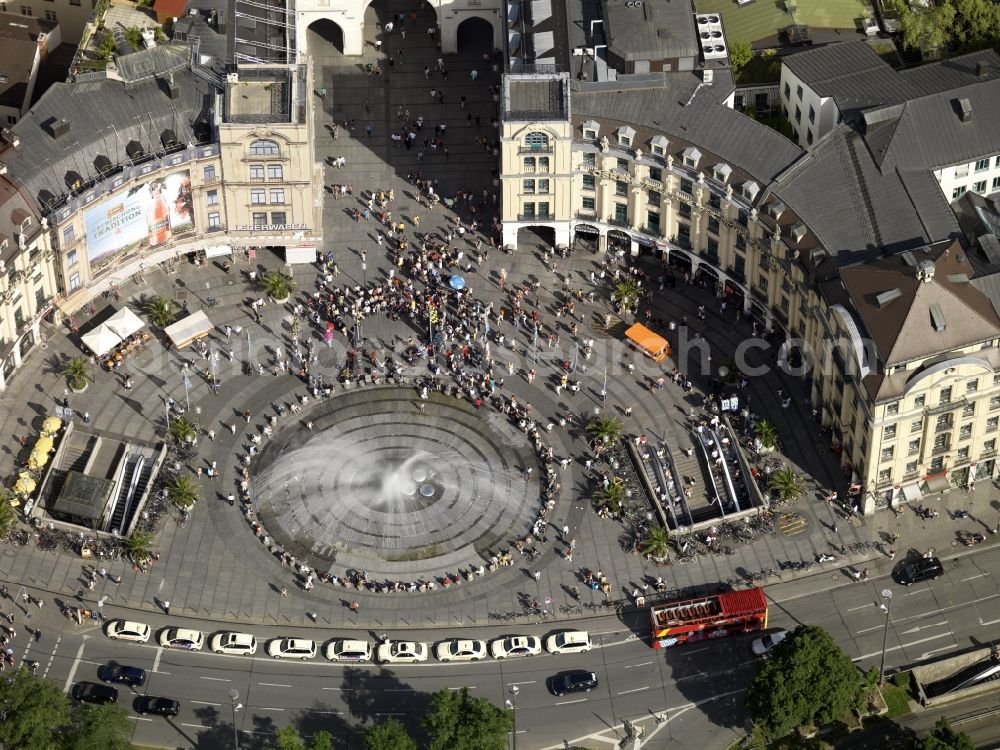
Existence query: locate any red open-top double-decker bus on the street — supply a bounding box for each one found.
[649,588,767,648]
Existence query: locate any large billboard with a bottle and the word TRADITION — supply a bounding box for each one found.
[84,169,194,270]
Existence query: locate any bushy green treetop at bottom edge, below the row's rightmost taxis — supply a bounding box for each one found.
[423,687,513,750]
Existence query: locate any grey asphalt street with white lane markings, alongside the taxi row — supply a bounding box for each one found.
[5,548,1000,750]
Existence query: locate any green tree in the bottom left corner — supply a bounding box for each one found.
[0,667,72,750]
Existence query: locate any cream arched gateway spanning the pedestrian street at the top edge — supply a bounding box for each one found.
[295,0,506,55]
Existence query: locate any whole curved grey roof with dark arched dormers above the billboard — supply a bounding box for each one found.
[0,45,214,209]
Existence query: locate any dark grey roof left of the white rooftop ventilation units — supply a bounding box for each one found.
[601,0,699,61]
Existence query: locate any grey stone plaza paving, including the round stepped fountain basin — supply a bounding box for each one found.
[0,3,984,627]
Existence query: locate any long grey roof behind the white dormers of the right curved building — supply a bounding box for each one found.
[572,73,802,184]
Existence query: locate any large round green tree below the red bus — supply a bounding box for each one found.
[746,625,863,737]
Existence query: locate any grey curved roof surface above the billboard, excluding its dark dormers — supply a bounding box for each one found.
[3,48,209,203]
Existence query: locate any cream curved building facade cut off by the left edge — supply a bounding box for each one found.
[0,177,56,391]
